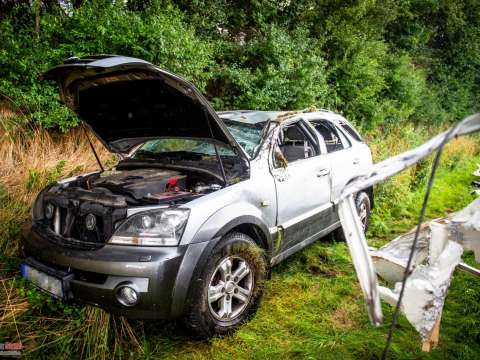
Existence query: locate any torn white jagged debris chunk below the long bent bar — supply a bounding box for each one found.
[371,199,480,341]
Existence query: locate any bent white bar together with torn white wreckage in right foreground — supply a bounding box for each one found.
[335,113,480,348]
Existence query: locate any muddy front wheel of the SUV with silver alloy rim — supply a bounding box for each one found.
[185,232,268,338]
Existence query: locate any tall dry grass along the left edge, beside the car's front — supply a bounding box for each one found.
[0,108,143,359]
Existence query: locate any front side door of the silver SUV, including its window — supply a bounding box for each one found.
[272,120,333,253]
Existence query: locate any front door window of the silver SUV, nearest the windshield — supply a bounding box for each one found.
[274,123,317,167]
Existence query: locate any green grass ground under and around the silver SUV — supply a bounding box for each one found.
[0,134,480,359]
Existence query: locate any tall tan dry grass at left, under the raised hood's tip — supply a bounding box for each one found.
[0,119,112,203]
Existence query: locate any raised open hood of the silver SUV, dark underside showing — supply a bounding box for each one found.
[41,55,247,158]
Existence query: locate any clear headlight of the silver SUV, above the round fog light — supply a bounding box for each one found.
[109,209,190,246]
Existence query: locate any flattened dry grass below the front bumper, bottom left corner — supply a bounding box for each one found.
[0,279,144,359]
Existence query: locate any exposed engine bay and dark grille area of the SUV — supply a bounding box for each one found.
[38,168,222,246]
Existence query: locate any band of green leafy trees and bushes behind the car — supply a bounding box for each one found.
[0,0,480,129]
